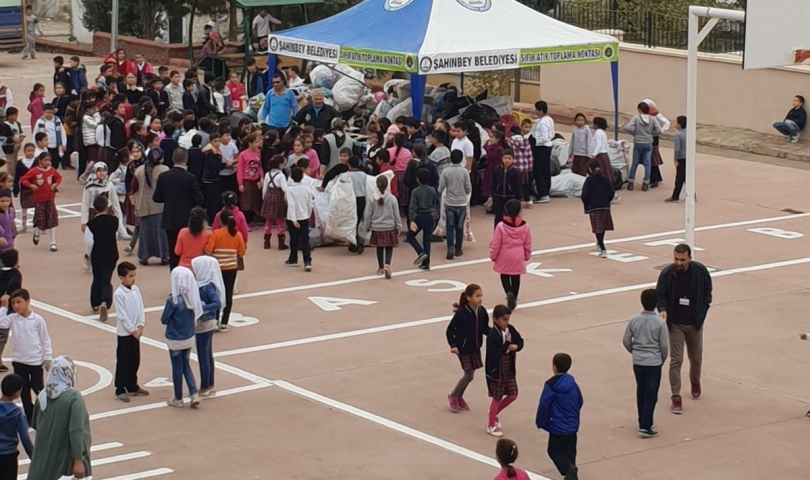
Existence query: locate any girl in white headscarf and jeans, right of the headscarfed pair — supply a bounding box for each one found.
[191,256,225,397]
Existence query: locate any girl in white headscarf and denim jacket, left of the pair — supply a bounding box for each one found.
[160,267,204,408]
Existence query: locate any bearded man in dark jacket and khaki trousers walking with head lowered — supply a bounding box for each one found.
[656,243,712,415]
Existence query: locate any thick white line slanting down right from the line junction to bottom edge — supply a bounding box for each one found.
[275,380,550,480]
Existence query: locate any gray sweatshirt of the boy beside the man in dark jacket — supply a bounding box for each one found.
[622,312,669,367]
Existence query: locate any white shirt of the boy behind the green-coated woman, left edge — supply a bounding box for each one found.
[0,307,53,366]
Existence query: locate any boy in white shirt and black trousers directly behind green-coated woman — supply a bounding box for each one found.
[0,288,53,425]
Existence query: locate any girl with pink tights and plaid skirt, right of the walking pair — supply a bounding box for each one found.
[486,305,523,437]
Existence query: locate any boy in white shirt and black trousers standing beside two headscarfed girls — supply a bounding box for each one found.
[113,262,149,403]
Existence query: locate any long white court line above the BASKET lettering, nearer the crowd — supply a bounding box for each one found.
[112,213,810,319]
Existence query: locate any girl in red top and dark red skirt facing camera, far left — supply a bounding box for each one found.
[20,152,62,252]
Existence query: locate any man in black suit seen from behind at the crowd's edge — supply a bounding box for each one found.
[152,147,204,269]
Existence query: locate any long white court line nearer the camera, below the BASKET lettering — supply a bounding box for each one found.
[214,257,810,358]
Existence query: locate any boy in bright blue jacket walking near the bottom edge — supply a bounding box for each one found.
[535,352,580,480]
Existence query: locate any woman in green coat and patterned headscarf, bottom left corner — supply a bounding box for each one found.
[28,356,92,480]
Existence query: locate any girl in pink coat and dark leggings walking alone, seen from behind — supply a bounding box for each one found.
[489,198,532,310]
